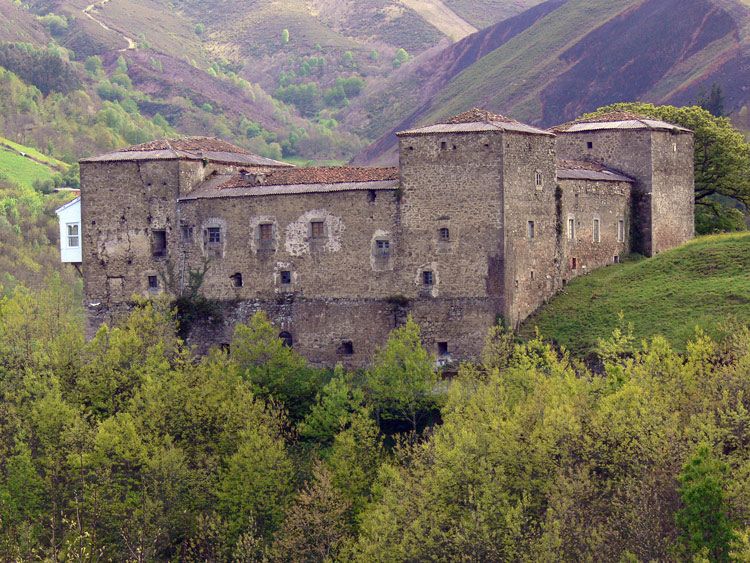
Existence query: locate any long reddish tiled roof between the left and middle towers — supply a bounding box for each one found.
[218,166,399,190]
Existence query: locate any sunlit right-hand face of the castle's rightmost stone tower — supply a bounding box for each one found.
[651,131,695,254]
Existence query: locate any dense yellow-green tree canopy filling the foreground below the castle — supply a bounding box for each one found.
[0,279,750,561]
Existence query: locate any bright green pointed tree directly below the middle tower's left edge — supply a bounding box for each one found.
[365,317,438,432]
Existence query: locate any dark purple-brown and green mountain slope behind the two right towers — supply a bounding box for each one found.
[356,0,750,162]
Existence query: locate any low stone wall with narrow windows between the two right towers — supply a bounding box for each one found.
[558,179,631,282]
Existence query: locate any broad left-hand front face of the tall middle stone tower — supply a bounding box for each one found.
[397,132,505,358]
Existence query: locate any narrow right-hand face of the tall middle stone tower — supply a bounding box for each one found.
[503,133,561,326]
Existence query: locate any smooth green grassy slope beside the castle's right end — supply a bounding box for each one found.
[522,233,750,353]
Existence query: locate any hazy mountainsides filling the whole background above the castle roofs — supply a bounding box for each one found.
[0,0,750,169]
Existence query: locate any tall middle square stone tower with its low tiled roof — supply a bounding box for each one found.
[399,110,559,330]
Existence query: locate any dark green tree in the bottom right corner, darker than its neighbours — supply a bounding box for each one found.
[675,444,734,561]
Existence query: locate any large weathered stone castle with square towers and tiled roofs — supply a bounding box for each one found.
[81,110,694,367]
